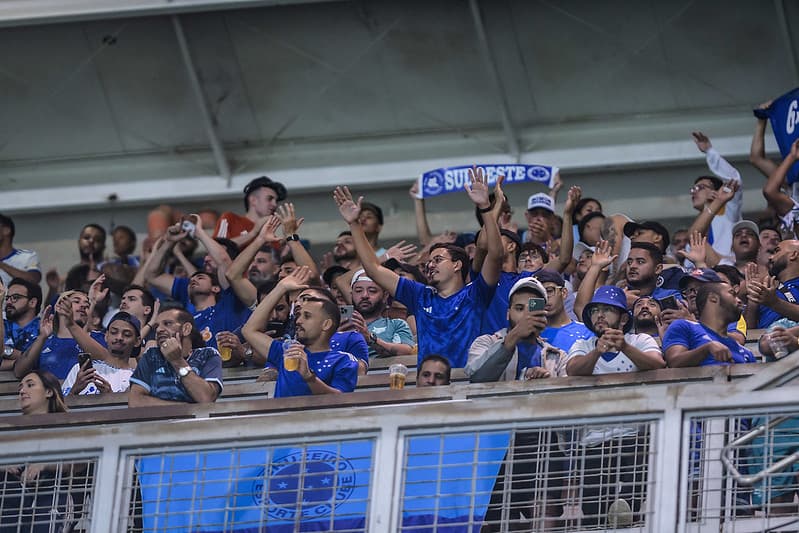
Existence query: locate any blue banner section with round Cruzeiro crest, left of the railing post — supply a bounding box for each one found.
[136,440,373,533]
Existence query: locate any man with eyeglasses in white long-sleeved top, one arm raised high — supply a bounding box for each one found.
[688,131,743,259]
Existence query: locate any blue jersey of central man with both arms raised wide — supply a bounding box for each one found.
[395,274,495,368]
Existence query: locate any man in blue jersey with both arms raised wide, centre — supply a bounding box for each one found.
[333,168,503,368]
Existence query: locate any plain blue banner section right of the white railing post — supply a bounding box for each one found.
[402,432,510,533]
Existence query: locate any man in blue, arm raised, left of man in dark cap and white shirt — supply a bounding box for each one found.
[14,291,105,380]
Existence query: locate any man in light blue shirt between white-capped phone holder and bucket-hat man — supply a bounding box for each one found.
[533,269,593,353]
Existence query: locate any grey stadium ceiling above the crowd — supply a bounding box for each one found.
[0,0,799,217]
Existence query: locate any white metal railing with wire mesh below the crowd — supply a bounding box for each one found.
[0,354,799,533]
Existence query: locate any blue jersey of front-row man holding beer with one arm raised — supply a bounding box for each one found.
[267,341,358,398]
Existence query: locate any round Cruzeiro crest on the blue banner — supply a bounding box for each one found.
[252,449,355,520]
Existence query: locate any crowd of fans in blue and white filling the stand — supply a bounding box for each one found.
[0,105,799,524]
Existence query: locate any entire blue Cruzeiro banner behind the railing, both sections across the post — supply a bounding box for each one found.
[136,432,510,533]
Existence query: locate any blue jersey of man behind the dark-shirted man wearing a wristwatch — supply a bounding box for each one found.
[172,278,252,348]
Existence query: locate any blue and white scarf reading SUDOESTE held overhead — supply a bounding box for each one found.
[418,164,558,198]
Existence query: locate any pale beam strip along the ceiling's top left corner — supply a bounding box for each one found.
[0,0,334,27]
